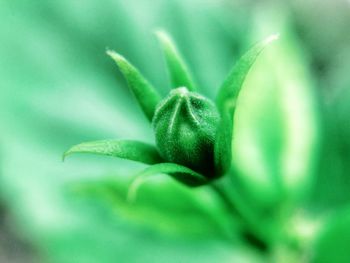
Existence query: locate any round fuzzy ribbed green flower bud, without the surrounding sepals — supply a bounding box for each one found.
[152,87,220,179]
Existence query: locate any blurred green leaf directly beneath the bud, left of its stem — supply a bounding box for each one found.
[68,174,237,242]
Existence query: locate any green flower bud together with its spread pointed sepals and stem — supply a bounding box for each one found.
[63,31,278,252]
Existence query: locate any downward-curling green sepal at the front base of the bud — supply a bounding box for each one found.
[128,163,208,194]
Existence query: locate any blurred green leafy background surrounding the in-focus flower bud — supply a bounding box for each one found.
[0,0,350,263]
